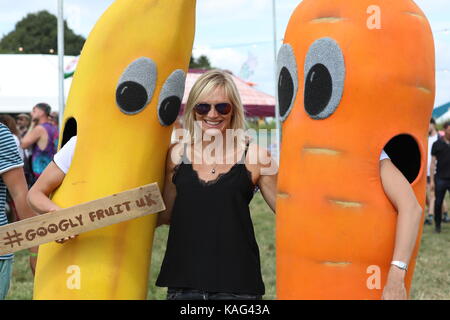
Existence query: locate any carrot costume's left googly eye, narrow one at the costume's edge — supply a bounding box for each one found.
[277,44,298,121]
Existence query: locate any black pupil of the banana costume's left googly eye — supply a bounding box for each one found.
[116,81,148,113]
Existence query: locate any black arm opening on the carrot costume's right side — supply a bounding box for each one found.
[384,134,421,184]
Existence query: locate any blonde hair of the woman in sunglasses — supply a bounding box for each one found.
[184,69,247,142]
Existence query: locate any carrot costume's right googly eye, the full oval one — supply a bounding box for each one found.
[304,38,345,120]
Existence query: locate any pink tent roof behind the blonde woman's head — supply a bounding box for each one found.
[181,69,275,118]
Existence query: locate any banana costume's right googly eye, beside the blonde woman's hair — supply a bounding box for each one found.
[158,70,186,126]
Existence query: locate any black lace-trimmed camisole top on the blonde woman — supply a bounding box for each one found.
[156,144,265,295]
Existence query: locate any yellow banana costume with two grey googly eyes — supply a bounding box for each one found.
[34,0,195,299]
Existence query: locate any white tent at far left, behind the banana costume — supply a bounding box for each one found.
[0,54,75,113]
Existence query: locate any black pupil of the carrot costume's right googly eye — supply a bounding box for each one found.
[305,63,333,116]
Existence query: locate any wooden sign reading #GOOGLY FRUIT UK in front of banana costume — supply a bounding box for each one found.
[0,183,165,255]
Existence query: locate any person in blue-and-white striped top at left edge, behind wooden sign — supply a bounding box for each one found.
[0,124,37,300]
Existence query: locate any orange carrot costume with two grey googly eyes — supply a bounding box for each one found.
[276,0,435,299]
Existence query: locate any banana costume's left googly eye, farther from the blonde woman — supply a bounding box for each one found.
[116,57,157,114]
